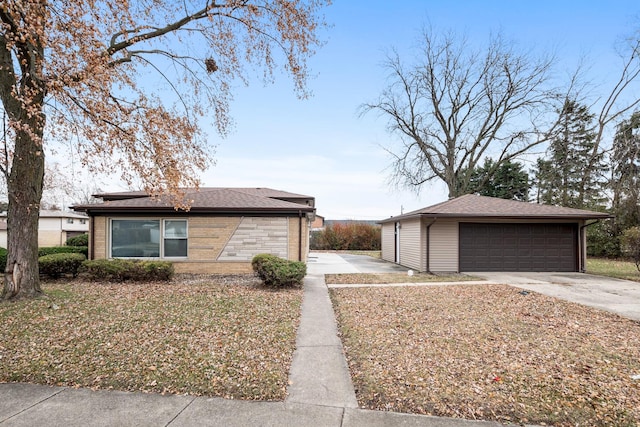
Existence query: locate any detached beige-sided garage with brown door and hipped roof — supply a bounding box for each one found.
[380,194,611,273]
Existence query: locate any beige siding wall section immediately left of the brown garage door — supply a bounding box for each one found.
[429,219,459,273]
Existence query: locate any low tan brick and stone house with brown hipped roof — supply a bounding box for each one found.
[73,188,315,274]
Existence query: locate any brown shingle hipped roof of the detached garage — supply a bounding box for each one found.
[381,194,611,222]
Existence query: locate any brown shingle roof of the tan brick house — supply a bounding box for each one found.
[73,188,313,216]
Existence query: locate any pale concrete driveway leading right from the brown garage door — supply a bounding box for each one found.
[466,272,640,321]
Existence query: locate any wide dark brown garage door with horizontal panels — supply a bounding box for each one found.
[460,223,578,271]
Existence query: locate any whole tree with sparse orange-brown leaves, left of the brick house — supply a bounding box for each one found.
[0,0,329,299]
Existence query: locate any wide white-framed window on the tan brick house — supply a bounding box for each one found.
[111,219,188,258]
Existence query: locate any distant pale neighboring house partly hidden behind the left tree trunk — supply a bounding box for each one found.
[0,210,89,248]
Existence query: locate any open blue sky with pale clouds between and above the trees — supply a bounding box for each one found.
[121,0,640,220]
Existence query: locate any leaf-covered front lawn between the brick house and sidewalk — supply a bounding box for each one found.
[0,277,302,400]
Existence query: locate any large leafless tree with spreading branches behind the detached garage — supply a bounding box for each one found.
[362,30,564,197]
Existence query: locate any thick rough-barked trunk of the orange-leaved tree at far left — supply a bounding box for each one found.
[0,0,49,299]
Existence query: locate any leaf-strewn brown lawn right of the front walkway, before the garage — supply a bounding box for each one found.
[331,285,640,426]
